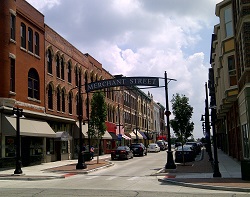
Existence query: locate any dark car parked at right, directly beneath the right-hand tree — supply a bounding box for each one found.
[175,145,196,163]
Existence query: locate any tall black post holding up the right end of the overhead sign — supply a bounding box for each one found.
[165,71,176,169]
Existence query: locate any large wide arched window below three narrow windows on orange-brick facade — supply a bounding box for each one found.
[28,68,40,100]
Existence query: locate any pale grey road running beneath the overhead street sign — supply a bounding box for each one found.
[0,151,249,197]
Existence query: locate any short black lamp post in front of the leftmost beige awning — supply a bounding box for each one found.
[13,107,23,174]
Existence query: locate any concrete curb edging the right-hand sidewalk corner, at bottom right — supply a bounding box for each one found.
[158,178,250,192]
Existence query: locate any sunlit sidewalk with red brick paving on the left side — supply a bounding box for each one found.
[0,155,113,180]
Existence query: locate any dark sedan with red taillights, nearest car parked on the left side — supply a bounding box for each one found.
[111,146,134,160]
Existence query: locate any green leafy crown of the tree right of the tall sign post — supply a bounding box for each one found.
[170,93,194,144]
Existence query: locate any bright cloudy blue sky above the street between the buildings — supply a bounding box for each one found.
[27,0,222,139]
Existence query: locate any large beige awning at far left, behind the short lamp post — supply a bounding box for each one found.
[2,116,56,138]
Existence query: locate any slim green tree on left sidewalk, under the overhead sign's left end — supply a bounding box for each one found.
[88,91,107,163]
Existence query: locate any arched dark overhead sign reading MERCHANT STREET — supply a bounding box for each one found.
[86,77,159,92]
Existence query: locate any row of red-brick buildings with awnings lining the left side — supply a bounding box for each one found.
[0,0,164,167]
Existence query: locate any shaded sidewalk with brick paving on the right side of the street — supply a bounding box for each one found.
[157,149,250,192]
